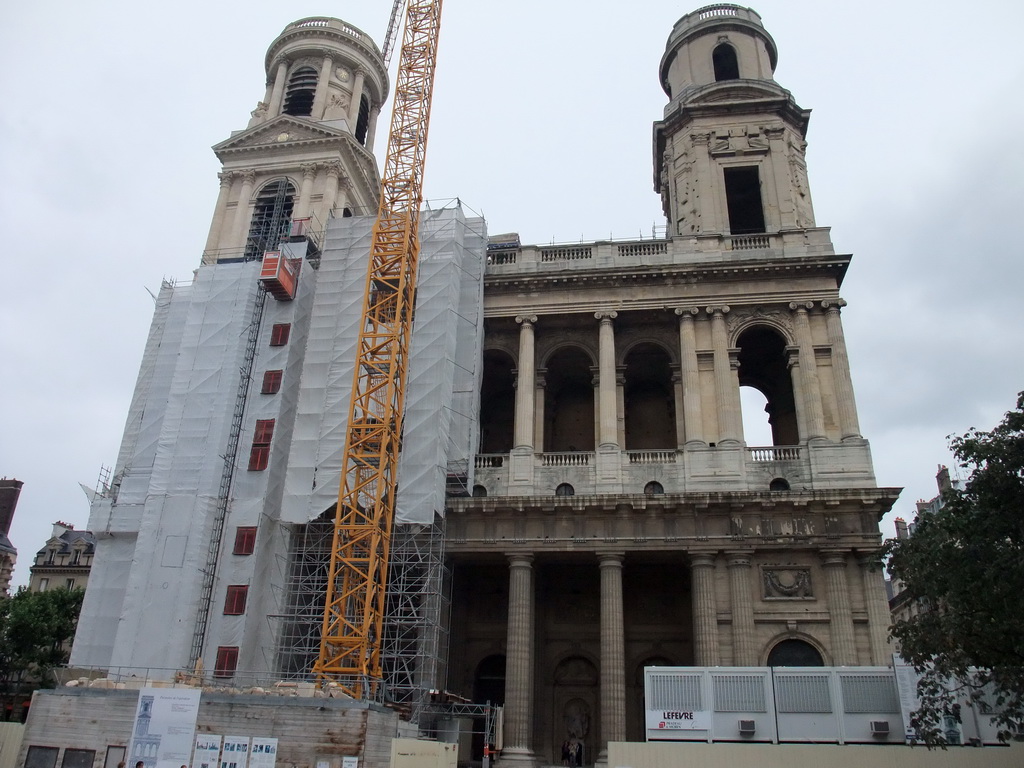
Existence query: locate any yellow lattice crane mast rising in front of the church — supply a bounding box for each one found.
[313,0,442,698]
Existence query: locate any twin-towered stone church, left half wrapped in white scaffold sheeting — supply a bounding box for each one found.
[72,5,899,764]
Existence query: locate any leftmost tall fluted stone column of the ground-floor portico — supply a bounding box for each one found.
[498,554,537,766]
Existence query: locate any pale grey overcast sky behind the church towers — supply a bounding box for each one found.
[0,0,1024,584]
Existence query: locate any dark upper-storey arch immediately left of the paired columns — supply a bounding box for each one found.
[624,344,676,451]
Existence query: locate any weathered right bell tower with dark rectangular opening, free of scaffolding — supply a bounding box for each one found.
[654,5,814,238]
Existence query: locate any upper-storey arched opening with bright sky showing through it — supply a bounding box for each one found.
[736,326,800,445]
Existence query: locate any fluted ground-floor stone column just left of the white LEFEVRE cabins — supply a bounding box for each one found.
[597,553,626,765]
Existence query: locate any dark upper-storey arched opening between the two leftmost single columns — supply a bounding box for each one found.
[544,347,594,453]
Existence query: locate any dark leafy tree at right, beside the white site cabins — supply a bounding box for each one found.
[883,392,1024,745]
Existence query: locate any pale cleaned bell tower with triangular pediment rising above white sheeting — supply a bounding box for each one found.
[203,17,388,264]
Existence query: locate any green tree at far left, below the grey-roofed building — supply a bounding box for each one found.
[0,587,85,720]
